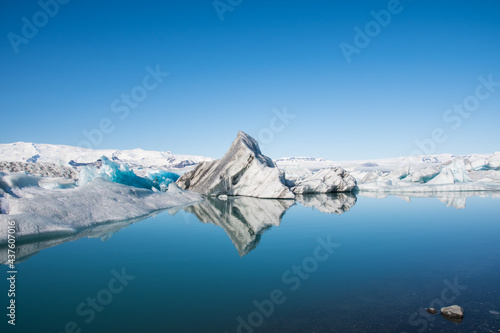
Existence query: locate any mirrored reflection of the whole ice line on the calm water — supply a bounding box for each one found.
[0,191,500,264]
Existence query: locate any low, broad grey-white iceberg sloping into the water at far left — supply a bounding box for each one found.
[0,175,203,244]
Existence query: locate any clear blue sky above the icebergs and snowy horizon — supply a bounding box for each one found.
[0,0,500,160]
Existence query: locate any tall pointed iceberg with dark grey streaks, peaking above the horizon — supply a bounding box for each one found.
[177,131,295,199]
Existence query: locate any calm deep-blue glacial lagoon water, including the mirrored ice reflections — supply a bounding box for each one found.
[0,193,500,333]
